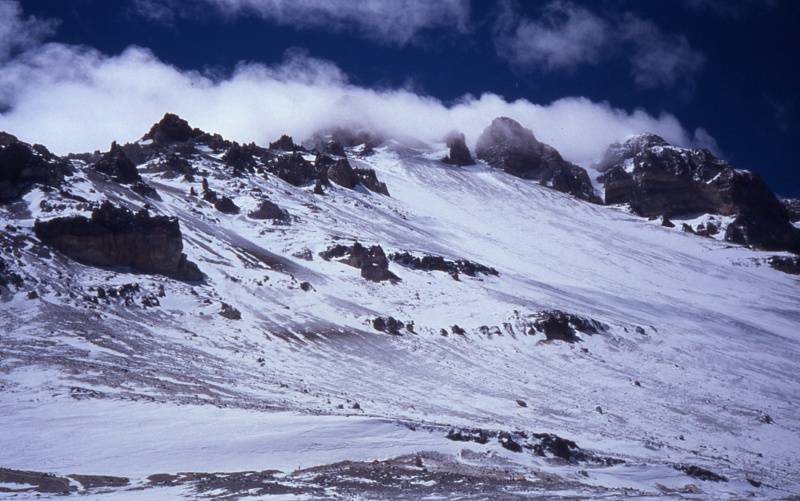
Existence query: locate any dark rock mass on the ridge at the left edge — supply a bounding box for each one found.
[0,132,72,203]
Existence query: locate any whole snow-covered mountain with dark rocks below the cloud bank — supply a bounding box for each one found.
[0,115,800,499]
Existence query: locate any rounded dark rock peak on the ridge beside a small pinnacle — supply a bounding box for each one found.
[475,117,599,202]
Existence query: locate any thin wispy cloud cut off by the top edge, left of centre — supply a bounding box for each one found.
[134,0,470,45]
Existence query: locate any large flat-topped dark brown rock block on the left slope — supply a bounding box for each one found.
[34,202,203,281]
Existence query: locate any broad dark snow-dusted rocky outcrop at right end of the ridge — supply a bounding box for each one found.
[597,134,800,252]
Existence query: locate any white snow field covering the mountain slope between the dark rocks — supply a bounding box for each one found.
[0,138,800,499]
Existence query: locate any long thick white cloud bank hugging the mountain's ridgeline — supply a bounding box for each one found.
[0,38,712,163]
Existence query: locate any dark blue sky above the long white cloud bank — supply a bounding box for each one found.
[15,0,800,196]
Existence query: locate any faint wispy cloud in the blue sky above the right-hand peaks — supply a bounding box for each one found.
[495,0,704,87]
